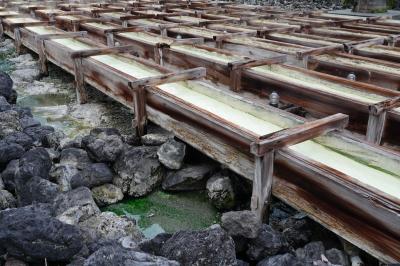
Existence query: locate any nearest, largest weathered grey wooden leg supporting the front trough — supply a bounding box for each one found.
[251,150,274,221]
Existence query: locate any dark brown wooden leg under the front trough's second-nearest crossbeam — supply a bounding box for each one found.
[133,86,147,137]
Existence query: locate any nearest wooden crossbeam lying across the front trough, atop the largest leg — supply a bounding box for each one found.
[250,113,349,156]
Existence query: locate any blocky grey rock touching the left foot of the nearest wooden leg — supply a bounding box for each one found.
[221,211,261,238]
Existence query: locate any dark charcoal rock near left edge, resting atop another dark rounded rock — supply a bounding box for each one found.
[16,148,52,182]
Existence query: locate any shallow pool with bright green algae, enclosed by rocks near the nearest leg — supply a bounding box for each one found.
[102,191,220,237]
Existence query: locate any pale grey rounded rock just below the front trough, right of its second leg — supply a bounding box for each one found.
[157,139,186,170]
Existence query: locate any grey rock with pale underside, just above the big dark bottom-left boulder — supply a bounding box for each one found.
[53,187,100,225]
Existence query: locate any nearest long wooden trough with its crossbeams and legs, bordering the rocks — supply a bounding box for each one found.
[2,6,400,263]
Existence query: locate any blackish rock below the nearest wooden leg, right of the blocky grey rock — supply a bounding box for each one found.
[246,224,286,261]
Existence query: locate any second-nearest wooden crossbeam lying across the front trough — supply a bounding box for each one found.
[129,67,206,90]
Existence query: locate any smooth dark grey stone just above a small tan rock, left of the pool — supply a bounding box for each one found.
[71,163,114,188]
